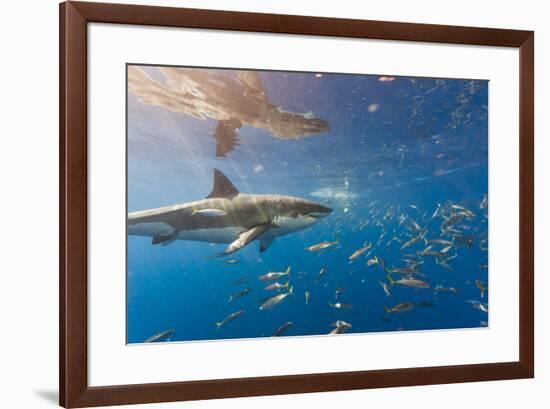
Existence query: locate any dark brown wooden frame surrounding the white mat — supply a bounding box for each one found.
[59,2,534,408]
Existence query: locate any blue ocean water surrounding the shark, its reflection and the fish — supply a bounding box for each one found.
[127,67,489,343]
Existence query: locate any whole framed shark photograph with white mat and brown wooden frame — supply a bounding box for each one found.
[60,2,534,407]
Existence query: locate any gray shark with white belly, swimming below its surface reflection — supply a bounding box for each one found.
[128,169,332,256]
